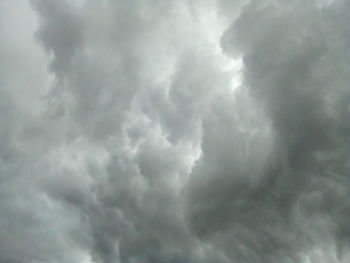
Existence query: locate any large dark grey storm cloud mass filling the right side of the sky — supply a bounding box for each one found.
[189,1,349,262]
